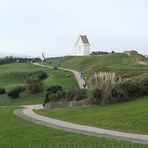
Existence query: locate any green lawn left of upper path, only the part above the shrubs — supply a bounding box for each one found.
[0,64,78,89]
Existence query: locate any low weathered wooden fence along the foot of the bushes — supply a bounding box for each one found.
[44,100,91,108]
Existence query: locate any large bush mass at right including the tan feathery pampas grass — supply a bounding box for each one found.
[90,74,148,104]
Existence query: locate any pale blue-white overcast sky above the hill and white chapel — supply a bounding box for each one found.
[0,0,148,56]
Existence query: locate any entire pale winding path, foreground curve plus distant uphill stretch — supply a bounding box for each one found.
[14,63,148,144]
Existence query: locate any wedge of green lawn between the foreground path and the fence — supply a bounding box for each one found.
[37,97,148,134]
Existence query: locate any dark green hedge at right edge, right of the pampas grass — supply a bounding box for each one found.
[109,77,148,103]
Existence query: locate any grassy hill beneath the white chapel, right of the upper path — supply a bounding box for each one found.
[48,53,148,77]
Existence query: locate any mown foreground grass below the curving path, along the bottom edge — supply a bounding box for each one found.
[0,106,147,148]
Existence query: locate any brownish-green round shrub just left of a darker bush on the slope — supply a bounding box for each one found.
[25,75,43,93]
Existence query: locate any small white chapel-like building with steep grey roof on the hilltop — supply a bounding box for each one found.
[75,35,90,56]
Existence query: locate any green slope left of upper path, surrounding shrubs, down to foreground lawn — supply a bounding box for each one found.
[0,63,78,106]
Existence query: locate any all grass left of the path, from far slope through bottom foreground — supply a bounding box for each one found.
[0,64,147,148]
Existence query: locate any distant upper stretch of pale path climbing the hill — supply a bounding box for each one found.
[33,63,88,89]
